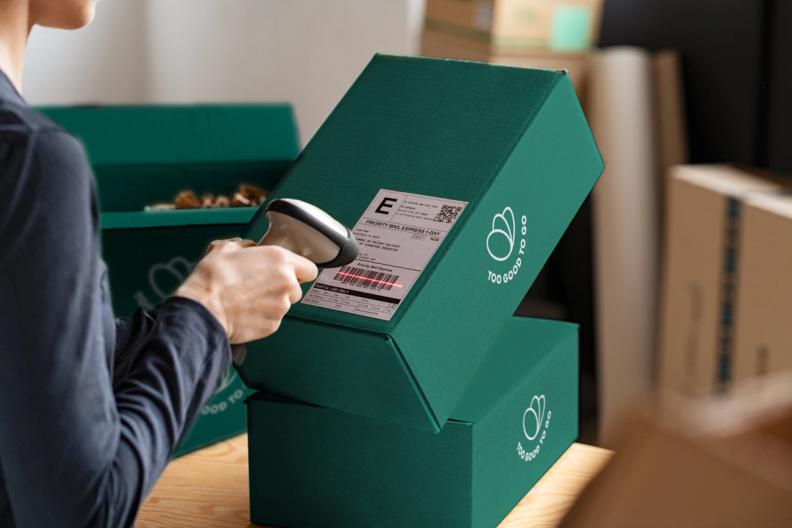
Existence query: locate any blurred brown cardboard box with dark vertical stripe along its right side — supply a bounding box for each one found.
[659,165,779,396]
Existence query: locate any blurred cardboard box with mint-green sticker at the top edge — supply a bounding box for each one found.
[426,0,602,51]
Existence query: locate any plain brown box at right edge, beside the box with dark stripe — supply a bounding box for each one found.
[733,195,792,383]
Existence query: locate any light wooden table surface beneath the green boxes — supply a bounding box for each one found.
[137,435,611,528]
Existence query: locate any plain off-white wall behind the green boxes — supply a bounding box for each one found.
[24,0,424,144]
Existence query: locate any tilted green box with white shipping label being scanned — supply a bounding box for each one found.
[238,55,603,432]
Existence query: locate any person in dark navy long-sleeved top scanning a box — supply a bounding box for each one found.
[0,0,317,527]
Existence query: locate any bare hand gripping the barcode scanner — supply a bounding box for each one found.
[175,239,318,344]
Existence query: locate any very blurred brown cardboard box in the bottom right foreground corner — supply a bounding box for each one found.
[559,375,792,528]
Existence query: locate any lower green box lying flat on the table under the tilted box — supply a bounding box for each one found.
[248,318,578,528]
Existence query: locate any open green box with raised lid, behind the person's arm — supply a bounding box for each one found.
[42,105,298,454]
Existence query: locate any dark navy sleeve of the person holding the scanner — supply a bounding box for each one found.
[0,130,230,527]
